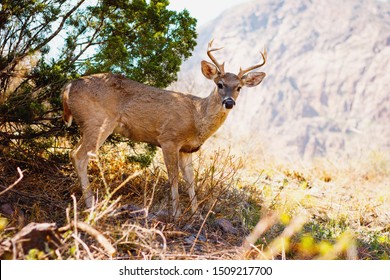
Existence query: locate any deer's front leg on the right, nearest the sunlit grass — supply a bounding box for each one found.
[179,153,198,213]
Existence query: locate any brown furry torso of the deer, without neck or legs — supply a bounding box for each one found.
[69,71,201,149]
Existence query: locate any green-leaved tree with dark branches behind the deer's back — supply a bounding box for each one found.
[0,0,196,165]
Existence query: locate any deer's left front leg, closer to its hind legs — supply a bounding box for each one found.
[161,144,181,219]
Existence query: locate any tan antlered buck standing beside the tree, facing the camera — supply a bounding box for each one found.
[62,41,267,218]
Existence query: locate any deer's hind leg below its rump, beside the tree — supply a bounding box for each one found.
[71,119,116,208]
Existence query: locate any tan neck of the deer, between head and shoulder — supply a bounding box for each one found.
[198,89,230,141]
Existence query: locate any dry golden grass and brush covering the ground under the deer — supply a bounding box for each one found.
[0,140,390,259]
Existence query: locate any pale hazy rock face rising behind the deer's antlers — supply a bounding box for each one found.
[173,0,390,159]
